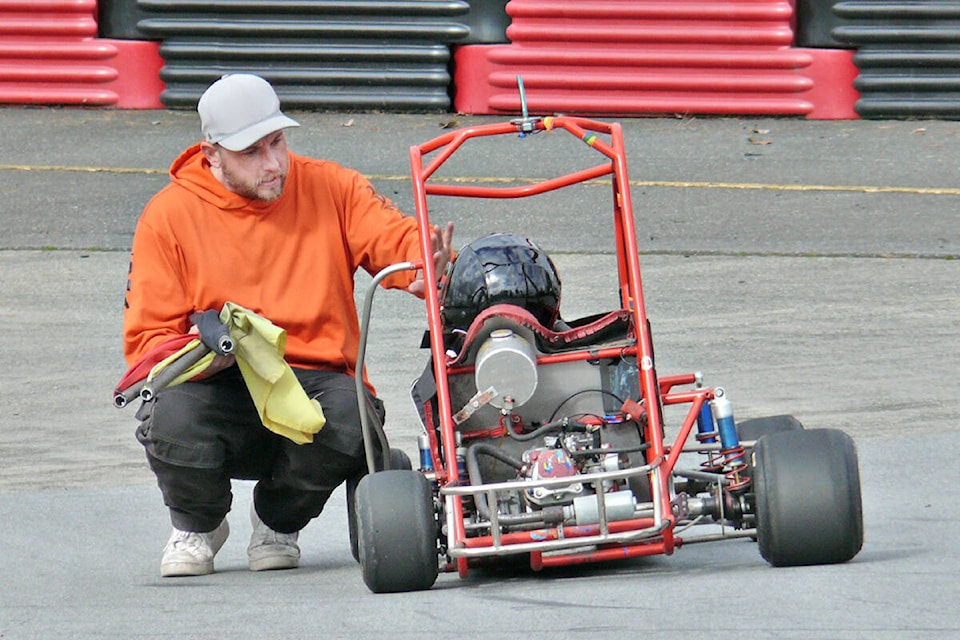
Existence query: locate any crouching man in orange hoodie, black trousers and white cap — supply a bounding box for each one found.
[123,74,453,576]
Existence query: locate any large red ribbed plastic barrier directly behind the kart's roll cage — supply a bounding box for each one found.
[454,0,857,119]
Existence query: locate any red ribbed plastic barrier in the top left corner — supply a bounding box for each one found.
[0,0,162,108]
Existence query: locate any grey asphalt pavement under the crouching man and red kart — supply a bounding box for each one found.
[0,108,960,640]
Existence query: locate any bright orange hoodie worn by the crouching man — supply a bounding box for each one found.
[123,144,420,382]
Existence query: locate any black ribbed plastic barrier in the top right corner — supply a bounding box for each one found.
[831,0,960,118]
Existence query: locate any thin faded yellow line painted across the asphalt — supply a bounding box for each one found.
[0,164,960,196]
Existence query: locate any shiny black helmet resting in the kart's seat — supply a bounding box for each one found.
[440,233,560,330]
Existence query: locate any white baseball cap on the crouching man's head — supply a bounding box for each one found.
[197,73,300,151]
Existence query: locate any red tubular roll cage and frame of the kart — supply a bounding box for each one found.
[410,116,713,576]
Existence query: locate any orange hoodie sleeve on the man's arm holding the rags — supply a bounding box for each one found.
[123,199,193,364]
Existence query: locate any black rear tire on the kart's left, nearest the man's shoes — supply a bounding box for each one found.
[356,469,439,593]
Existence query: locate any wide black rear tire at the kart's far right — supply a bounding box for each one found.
[752,429,863,567]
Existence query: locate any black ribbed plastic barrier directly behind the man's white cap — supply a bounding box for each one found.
[137,0,478,110]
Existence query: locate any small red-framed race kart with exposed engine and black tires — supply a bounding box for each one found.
[349,115,863,593]
